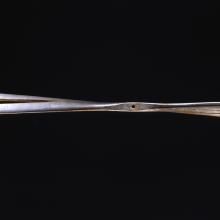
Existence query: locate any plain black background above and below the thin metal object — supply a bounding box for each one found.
[0,0,220,219]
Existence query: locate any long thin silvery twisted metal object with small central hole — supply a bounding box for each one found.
[0,94,220,117]
